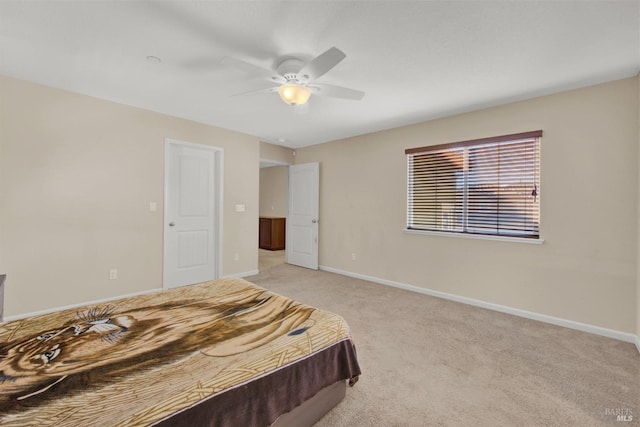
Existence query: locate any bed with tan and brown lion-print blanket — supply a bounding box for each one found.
[0,279,360,427]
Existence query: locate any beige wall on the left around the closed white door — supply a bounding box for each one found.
[0,77,260,316]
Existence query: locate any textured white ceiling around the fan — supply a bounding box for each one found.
[0,0,640,148]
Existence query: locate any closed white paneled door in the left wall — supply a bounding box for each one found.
[163,140,222,288]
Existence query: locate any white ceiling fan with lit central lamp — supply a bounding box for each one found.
[222,47,364,106]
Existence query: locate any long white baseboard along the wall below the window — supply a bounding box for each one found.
[319,265,640,352]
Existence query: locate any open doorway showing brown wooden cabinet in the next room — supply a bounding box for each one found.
[258,161,289,271]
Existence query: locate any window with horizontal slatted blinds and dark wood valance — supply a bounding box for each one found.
[405,131,542,239]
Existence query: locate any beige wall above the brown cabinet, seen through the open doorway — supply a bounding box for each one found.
[260,166,289,217]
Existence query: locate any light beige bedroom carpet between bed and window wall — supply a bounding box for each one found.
[248,264,640,427]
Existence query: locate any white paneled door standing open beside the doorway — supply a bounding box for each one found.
[286,163,320,270]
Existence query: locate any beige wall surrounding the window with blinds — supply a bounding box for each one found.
[296,78,639,333]
